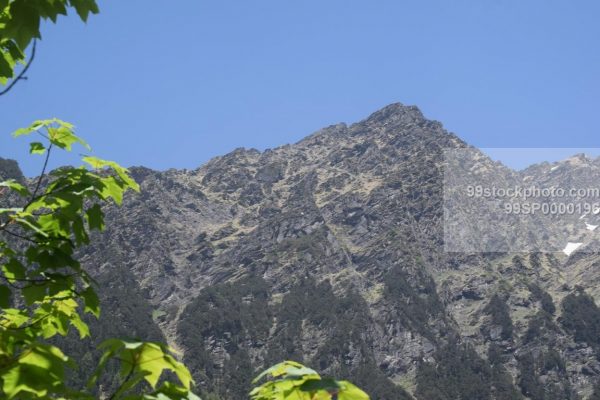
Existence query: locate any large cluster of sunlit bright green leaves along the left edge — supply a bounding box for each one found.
[0,119,198,400]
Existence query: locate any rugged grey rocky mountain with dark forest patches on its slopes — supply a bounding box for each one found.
[0,104,600,400]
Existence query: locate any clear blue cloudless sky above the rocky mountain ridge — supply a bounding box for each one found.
[0,0,600,175]
